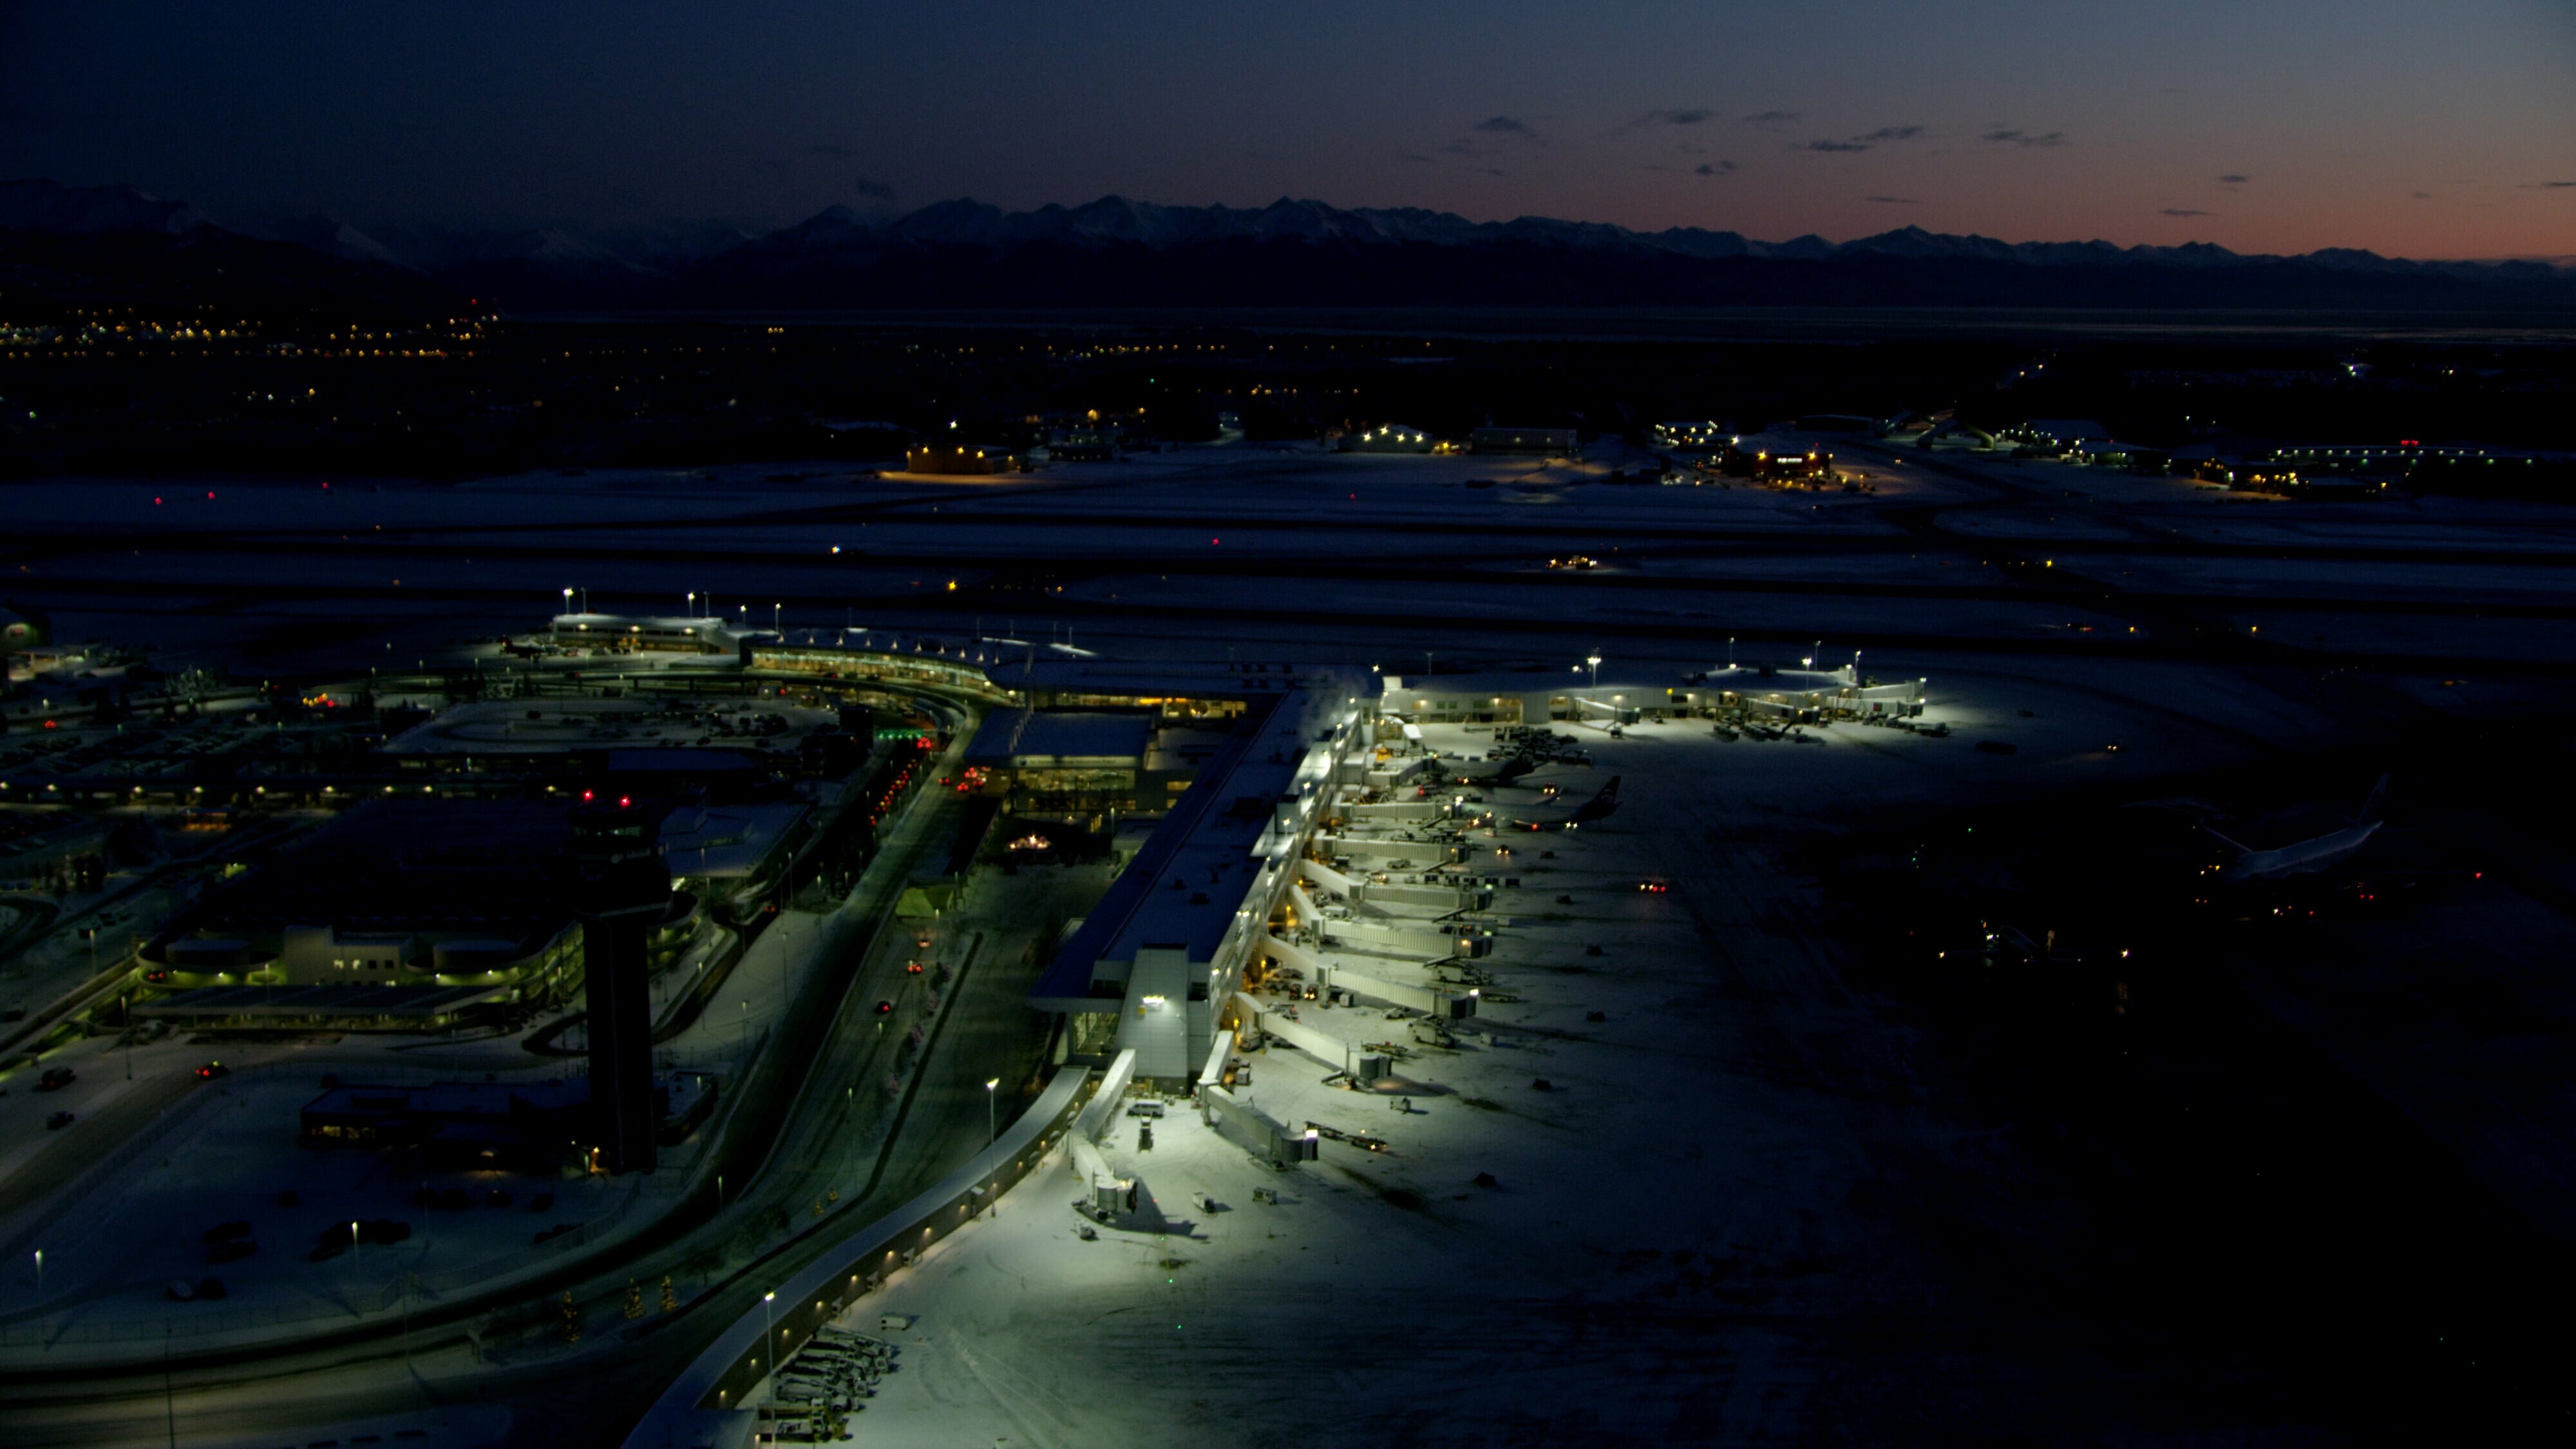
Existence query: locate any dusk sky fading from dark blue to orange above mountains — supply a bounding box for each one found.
[0,0,2576,258]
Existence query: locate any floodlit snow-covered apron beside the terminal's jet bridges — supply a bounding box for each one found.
[752,673,2360,1446]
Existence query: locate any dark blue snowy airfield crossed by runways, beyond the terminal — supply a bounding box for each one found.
[8,439,2576,673]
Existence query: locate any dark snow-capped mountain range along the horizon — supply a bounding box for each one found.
[0,180,2576,312]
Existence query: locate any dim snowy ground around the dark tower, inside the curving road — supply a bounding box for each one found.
[0,897,845,1346]
